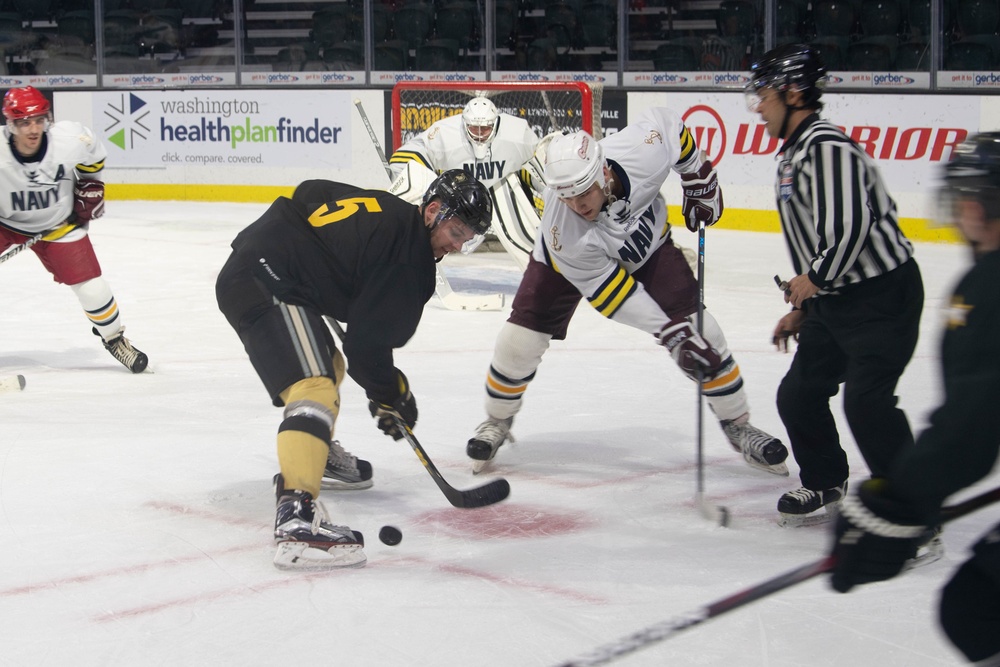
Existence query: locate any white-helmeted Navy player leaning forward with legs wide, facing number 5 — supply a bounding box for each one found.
[466,108,788,475]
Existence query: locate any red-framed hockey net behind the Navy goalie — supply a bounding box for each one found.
[392,81,603,150]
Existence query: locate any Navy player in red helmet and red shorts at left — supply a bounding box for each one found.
[0,86,148,373]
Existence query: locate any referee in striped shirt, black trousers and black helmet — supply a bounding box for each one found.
[746,44,924,525]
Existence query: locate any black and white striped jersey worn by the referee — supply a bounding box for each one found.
[775,114,913,294]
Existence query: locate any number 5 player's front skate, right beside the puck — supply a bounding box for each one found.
[274,474,368,570]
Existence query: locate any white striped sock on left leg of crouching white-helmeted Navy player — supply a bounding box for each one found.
[486,322,552,419]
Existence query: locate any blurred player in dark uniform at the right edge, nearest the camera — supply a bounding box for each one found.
[831,132,1000,666]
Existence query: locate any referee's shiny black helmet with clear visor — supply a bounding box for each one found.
[744,44,826,108]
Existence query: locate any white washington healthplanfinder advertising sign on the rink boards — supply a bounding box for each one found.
[93,90,352,169]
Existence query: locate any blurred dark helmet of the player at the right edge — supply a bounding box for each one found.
[942,132,1000,220]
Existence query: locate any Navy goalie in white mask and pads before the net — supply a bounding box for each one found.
[389,97,544,269]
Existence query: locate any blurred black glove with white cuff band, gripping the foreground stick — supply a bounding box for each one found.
[830,479,933,593]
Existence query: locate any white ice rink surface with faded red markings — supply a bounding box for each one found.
[0,202,1000,667]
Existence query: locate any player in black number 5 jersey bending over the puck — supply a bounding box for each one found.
[216,169,492,569]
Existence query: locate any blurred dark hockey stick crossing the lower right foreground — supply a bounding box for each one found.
[558,487,1000,667]
